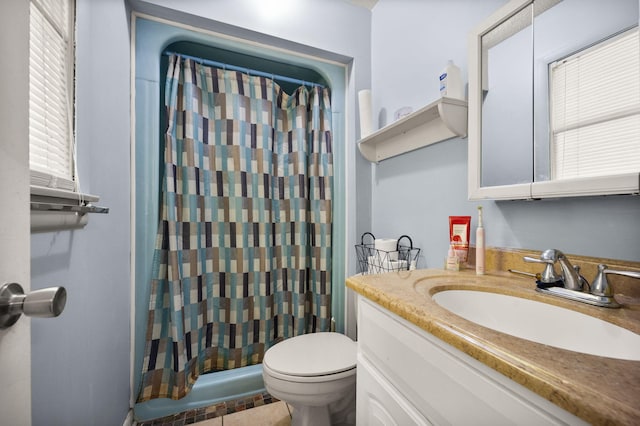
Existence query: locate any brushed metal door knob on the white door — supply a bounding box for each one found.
[0,283,67,329]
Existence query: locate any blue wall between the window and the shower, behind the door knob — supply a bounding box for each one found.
[30,0,131,426]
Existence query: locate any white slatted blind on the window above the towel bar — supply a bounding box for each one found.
[29,0,77,191]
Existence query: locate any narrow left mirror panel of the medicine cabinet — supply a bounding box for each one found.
[480,4,534,186]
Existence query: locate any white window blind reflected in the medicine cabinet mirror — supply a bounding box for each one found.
[549,28,640,179]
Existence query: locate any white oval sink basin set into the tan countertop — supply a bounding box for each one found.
[432,290,640,361]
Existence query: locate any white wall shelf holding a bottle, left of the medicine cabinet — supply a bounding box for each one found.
[358,98,467,163]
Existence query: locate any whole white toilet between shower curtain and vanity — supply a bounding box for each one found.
[262,332,357,426]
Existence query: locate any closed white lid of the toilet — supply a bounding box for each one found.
[262,333,357,377]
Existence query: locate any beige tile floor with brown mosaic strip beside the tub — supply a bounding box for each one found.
[138,392,291,426]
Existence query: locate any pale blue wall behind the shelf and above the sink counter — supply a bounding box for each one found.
[372,0,640,268]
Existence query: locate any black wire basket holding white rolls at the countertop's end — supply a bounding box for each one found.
[356,232,420,274]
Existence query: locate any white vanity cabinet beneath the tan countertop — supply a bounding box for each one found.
[357,296,586,425]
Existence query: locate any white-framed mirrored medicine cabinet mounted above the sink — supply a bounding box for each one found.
[468,0,640,200]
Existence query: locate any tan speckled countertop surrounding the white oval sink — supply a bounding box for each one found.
[347,269,640,424]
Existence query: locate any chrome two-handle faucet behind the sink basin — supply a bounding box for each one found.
[524,249,640,308]
